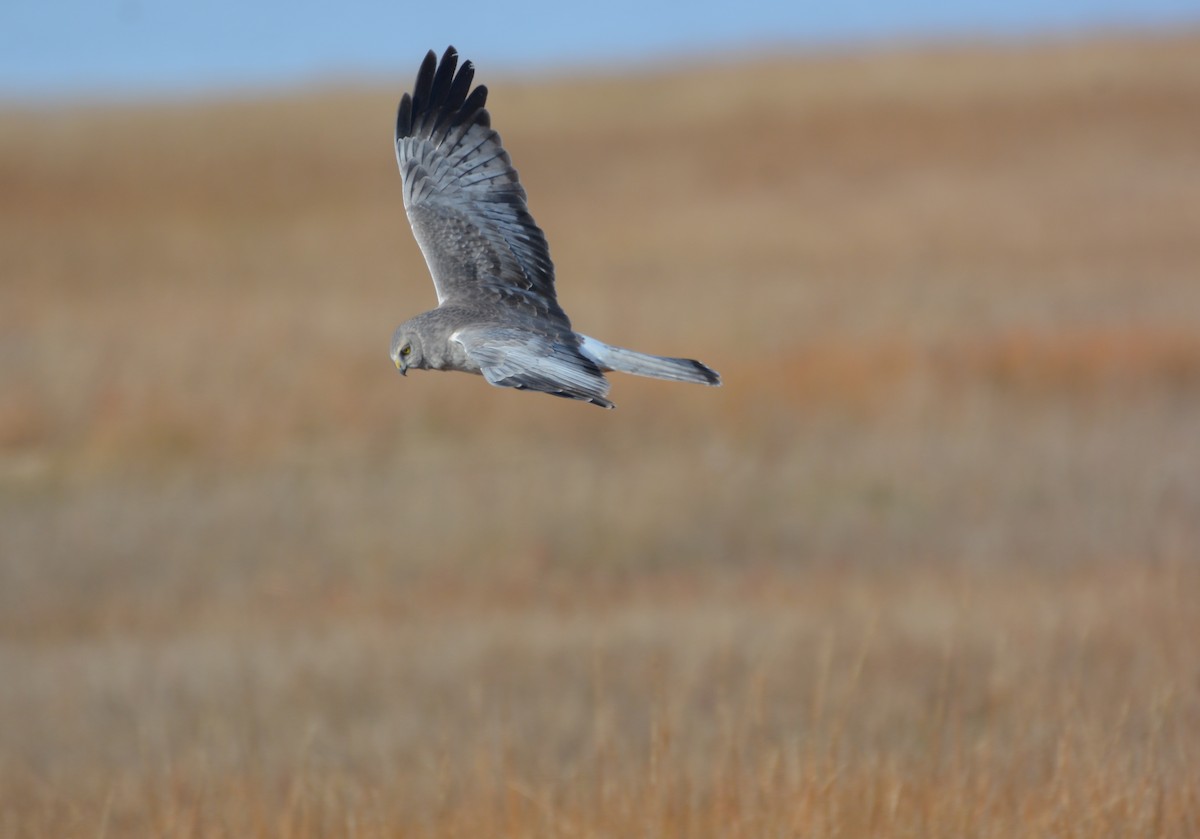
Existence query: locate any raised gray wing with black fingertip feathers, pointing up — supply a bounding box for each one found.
[396,47,569,329]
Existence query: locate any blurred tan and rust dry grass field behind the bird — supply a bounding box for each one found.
[0,27,1200,839]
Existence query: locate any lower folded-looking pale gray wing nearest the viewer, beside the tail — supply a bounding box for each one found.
[451,326,613,408]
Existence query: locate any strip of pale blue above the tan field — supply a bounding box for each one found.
[0,0,1200,101]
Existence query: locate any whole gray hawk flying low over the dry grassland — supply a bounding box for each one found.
[391,47,721,408]
